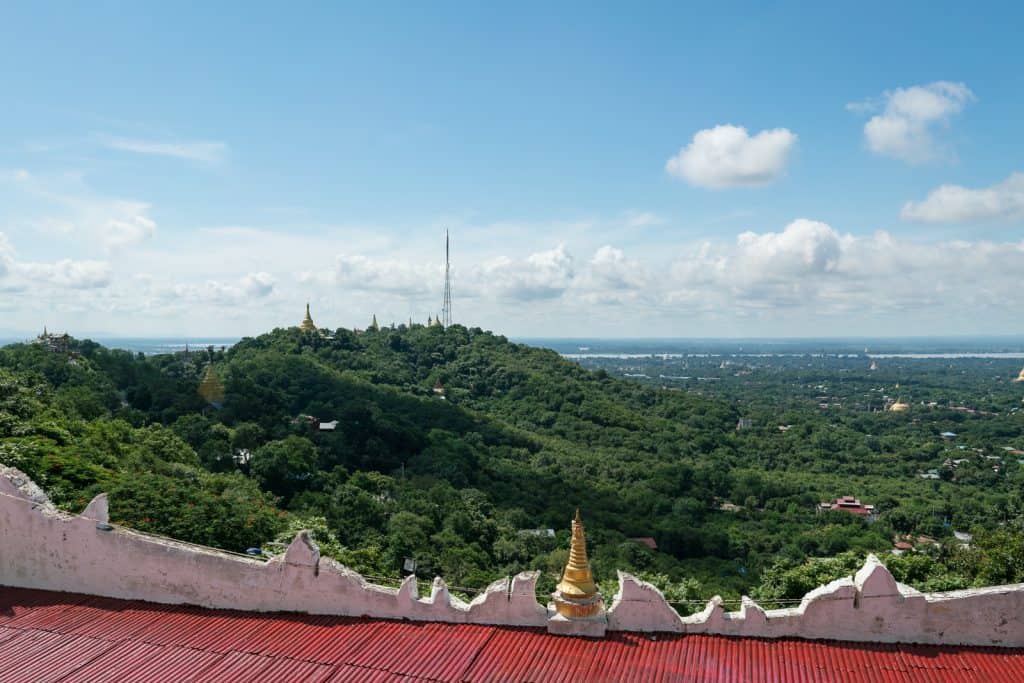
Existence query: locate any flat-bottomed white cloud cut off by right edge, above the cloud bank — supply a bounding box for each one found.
[900,173,1024,223]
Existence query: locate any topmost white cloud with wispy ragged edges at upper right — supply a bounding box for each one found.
[847,81,976,164]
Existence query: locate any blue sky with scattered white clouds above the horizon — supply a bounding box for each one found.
[0,3,1024,336]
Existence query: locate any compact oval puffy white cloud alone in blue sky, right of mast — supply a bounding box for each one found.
[665,125,797,189]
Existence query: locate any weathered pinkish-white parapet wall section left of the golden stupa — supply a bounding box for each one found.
[0,467,548,627]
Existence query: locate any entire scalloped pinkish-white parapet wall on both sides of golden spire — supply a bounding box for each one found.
[0,466,1024,647]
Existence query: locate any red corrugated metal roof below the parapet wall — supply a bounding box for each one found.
[0,588,1024,683]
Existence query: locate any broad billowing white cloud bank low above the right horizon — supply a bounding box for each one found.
[665,219,1024,315]
